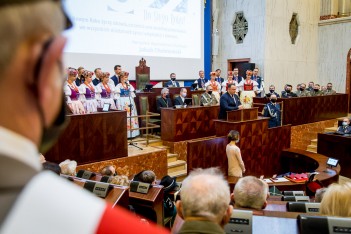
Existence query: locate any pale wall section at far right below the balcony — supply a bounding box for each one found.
[319,17,351,93]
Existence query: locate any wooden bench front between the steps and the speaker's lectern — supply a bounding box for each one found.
[161,106,219,142]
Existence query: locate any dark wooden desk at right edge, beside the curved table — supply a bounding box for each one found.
[317,133,351,178]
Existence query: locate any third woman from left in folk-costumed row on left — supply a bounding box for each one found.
[96,72,117,109]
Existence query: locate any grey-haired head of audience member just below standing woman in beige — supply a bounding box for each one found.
[231,176,269,210]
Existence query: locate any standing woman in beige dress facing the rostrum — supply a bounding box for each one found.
[226,130,245,177]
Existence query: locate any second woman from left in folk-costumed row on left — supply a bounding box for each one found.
[79,71,99,114]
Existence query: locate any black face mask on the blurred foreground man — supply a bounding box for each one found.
[39,95,69,154]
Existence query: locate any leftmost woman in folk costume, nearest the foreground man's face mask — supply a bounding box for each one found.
[63,68,85,115]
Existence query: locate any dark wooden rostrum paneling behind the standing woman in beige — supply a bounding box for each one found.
[187,119,291,176]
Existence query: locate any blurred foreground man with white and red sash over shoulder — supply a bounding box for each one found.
[0,0,165,233]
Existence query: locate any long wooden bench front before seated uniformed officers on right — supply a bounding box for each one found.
[253,94,348,126]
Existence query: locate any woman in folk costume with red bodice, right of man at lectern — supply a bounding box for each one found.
[238,70,258,108]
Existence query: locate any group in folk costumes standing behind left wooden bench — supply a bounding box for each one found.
[64,65,140,137]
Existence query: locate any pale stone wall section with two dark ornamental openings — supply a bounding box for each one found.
[213,0,320,91]
